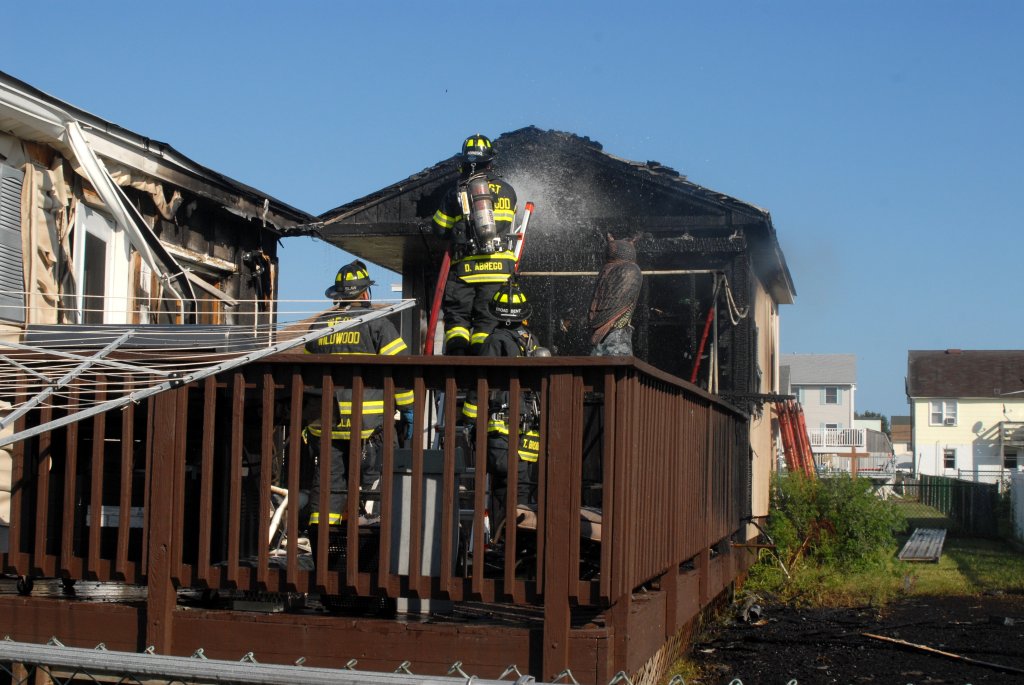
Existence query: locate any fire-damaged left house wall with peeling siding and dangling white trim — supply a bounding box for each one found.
[0,72,312,326]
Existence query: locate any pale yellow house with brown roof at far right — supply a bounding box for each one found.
[906,349,1024,482]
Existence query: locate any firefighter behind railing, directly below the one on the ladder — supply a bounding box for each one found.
[462,280,551,539]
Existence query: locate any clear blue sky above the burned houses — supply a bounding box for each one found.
[0,0,1024,415]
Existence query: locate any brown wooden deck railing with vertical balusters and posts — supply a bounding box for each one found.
[2,354,750,662]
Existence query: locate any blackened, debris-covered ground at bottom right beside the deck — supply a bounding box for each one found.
[686,595,1024,685]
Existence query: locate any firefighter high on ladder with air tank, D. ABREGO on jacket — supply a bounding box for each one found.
[433,133,516,355]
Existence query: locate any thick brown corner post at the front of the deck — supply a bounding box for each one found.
[538,374,582,681]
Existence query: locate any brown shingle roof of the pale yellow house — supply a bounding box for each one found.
[906,349,1024,398]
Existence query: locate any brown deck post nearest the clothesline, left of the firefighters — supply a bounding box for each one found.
[145,388,181,654]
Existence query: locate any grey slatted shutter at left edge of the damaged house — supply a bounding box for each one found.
[0,164,25,324]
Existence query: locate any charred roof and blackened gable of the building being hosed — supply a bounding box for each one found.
[319,126,796,304]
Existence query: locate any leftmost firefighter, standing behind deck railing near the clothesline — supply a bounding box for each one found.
[303,260,413,525]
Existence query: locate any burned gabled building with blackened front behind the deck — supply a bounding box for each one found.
[319,127,796,515]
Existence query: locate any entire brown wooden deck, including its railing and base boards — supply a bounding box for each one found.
[0,355,754,683]
